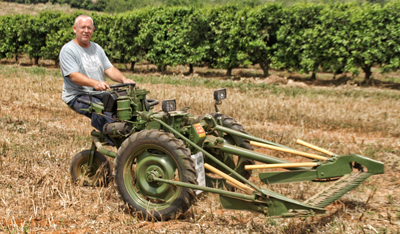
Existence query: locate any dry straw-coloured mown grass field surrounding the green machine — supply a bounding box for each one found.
[0,66,400,233]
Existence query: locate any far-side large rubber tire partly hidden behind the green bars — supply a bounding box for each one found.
[199,113,254,188]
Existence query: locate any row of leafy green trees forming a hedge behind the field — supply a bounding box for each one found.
[0,1,400,79]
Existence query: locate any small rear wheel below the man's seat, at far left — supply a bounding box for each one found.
[70,150,111,186]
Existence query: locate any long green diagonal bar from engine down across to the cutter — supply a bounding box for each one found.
[154,118,265,194]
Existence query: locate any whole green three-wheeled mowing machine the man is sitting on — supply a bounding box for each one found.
[70,83,384,220]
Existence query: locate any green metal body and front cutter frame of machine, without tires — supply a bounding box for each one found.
[75,85,384,217]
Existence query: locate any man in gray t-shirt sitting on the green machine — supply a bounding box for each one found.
[60,15,134,145]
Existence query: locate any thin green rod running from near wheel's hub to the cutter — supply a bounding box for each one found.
[153,177,255,201]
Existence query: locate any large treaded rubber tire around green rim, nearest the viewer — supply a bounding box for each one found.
[114,130,197,221]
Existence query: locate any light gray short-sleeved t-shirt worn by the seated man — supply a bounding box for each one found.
[60,41,113,103]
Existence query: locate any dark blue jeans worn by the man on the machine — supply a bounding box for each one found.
[67,95,115,146]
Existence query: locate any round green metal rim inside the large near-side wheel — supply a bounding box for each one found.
[123,144,182,210]
